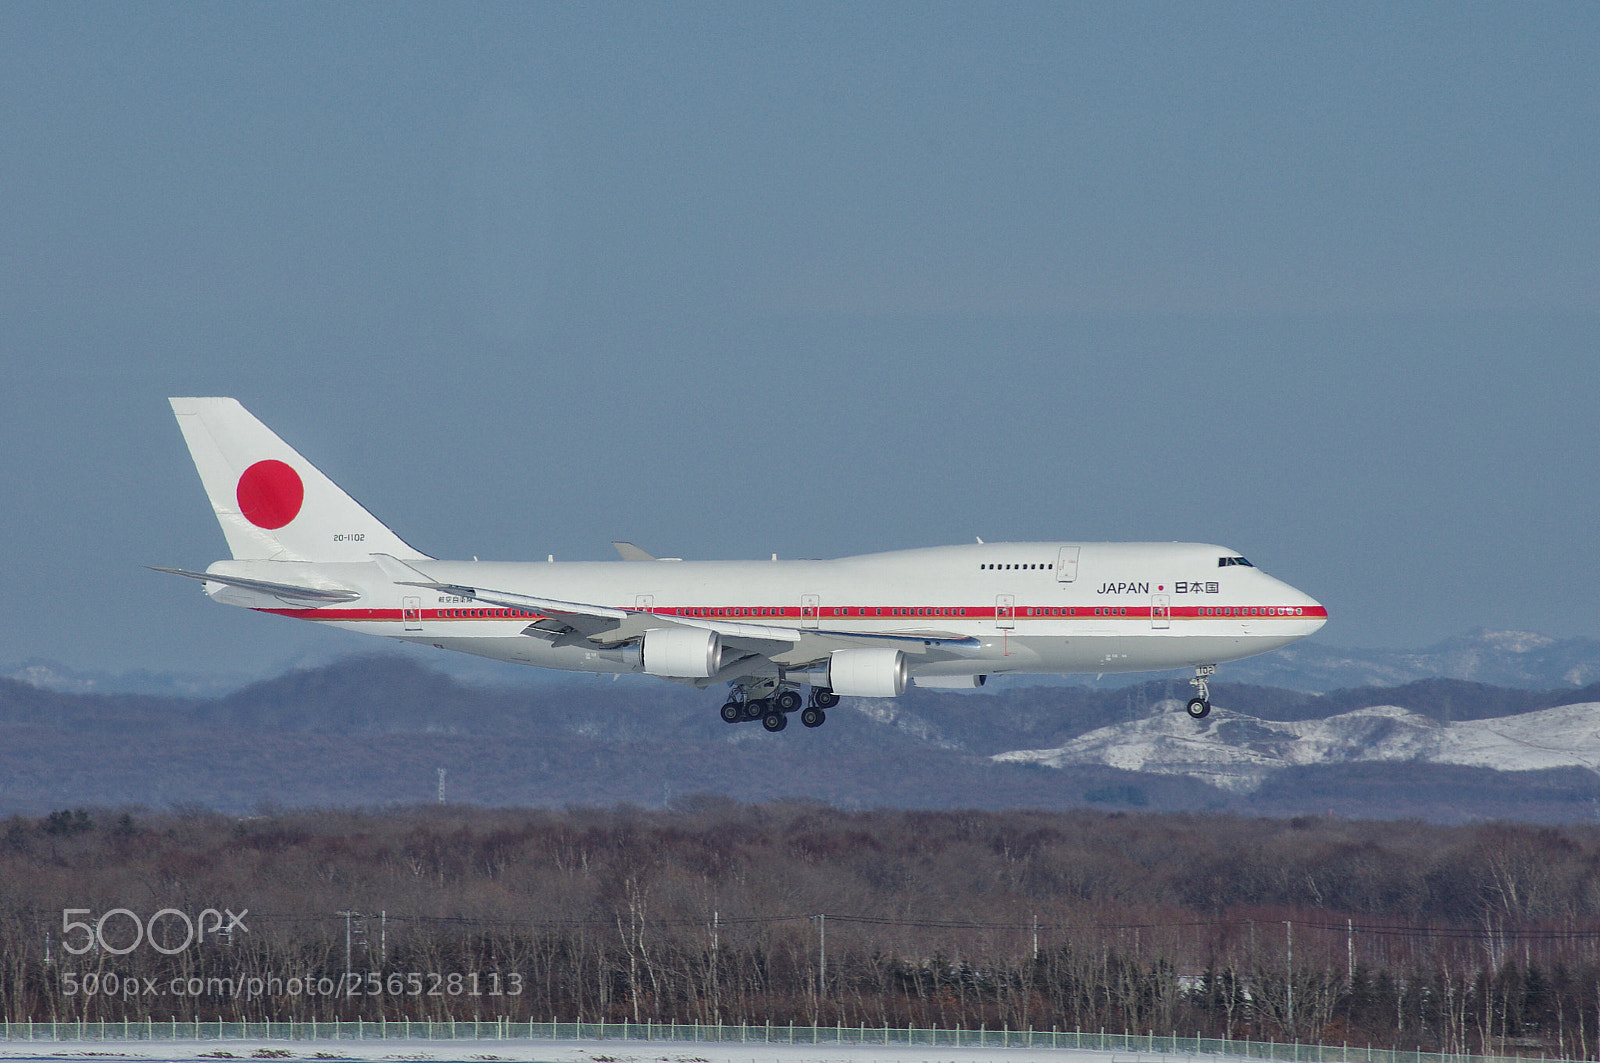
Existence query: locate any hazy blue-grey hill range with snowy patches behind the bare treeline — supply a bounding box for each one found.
[0,656,1600,821]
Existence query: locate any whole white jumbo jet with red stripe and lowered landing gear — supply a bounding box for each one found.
[152,399,1328,732]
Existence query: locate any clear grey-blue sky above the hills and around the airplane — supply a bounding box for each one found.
[0,3,1600,672]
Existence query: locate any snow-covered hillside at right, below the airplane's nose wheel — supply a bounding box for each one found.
[992,701,1600,792]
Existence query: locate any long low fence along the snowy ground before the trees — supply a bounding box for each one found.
[0,1018,1562,1063]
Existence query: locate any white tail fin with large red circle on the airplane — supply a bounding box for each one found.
[170,399,427,562]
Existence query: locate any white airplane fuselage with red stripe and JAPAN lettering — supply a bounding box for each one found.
[206,543,1326,685]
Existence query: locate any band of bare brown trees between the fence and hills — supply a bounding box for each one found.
[9,810,1600,1058]
